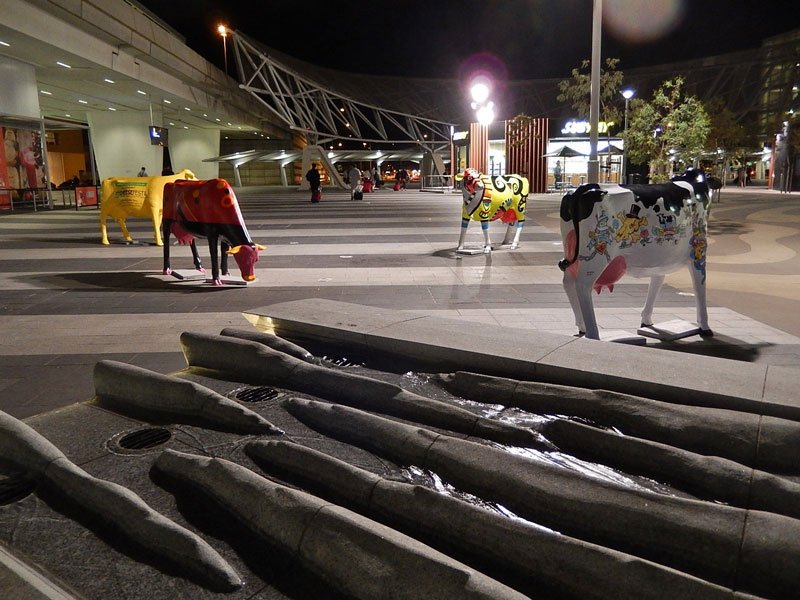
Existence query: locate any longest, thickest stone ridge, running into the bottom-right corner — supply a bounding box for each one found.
[286,398,800,598]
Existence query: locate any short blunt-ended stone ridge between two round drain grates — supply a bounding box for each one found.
[94,360,283,434]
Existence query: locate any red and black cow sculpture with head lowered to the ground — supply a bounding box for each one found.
[161,179,264,285]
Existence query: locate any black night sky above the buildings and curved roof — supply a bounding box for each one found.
[134,0,800,80]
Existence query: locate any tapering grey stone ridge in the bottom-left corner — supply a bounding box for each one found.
[0,412,243,591]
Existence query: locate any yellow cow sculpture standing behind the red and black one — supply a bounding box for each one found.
[100,169,197,246]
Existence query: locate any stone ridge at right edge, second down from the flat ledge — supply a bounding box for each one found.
[537,419,800,519]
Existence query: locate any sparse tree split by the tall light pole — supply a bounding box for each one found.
[557,58,625,132]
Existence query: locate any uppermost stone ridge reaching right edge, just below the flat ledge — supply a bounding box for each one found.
[439,371,800,473]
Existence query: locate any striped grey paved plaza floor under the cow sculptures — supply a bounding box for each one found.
[0,183,800,418]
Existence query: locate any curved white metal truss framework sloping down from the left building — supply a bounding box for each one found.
[231,31,453,150]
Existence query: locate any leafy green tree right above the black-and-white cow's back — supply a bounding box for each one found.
[625,77,710,182]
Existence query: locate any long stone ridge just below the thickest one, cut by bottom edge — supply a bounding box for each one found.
[246,441,744,600]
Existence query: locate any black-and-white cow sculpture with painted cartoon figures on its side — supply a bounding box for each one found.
[558,169,712,339]
